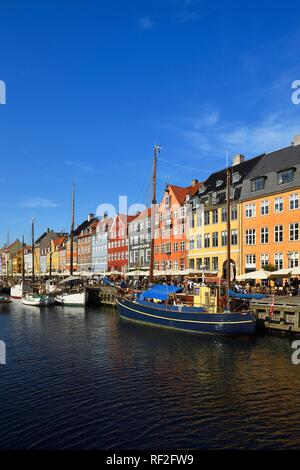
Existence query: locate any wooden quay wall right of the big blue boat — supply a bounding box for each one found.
[251,296,300,334]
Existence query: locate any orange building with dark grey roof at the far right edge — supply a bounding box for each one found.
[240,138,300,272]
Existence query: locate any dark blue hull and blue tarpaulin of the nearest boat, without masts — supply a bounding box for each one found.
[117,285,256,336]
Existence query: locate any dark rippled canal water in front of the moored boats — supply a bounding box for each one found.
[0,301,300,449]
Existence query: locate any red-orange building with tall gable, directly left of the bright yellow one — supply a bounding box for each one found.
[154,180,202,271]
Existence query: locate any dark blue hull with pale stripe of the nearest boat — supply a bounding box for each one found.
[117,299,256,336]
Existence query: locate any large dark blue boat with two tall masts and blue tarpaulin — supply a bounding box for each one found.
[117,146,255,336]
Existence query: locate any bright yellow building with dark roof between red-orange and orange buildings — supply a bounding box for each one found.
[187,155,261,277]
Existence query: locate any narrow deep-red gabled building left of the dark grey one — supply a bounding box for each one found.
[108,214,135,272]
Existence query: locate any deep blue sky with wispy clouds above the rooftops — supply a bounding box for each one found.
[0,0,300,243]
